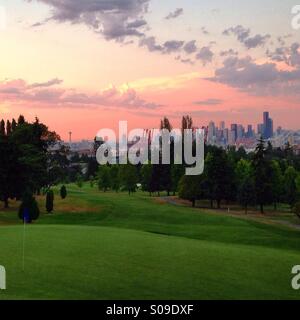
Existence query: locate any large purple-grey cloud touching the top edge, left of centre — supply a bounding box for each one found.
[27,0,150,41]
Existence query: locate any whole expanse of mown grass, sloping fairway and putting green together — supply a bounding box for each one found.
[0,186,300,299]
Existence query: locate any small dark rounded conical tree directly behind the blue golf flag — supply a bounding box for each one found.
[19,190,40,223]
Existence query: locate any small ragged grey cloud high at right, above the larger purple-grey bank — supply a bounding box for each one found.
[223,25,271,49]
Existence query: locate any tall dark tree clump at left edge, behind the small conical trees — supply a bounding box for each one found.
[0,116,60,220]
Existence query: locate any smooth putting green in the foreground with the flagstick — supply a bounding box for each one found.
[0,225,300,299]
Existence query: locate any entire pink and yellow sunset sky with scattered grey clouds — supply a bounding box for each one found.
[0,0,300,139]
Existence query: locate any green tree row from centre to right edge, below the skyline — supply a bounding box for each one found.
[89,117,300,213]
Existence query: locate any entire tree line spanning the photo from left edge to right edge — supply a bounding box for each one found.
[0,116,300,217]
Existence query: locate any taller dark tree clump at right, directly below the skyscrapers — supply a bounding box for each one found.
[179,139,300,213]
